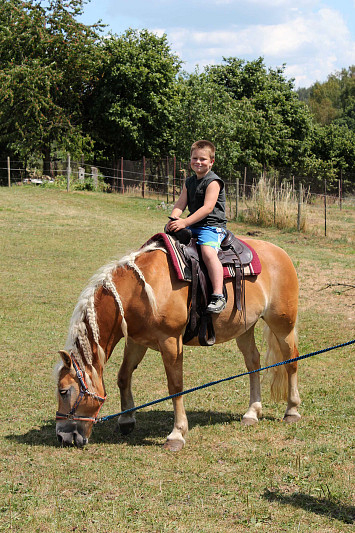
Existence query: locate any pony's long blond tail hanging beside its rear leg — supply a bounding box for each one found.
[264,324,288,402]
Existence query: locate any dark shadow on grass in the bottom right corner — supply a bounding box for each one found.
[263,489,355,524]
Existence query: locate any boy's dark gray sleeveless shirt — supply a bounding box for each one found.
[185,170,227,228]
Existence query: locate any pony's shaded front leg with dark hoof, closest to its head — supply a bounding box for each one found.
[117,339,147,435]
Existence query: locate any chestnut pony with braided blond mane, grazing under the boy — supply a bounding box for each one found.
[56,239,300,451]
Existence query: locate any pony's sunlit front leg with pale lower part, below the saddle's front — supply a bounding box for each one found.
[159,336,188,452]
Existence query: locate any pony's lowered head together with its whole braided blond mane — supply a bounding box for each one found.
[56,245,156,447]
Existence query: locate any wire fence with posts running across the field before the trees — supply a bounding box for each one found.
[0,155,355,235]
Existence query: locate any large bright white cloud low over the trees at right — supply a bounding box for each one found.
[168,6,355,86]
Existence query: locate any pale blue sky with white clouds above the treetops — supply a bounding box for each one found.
[80,0,355,88]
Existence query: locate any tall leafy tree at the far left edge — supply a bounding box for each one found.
[0,0,103,173]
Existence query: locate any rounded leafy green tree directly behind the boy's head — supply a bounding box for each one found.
[179,58,311,174]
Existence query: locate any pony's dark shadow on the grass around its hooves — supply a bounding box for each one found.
[6,410,256,447]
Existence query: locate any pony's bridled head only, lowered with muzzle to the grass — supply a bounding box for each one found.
[56,350,106,447]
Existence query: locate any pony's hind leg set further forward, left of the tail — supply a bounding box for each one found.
[237,326,262,426]
